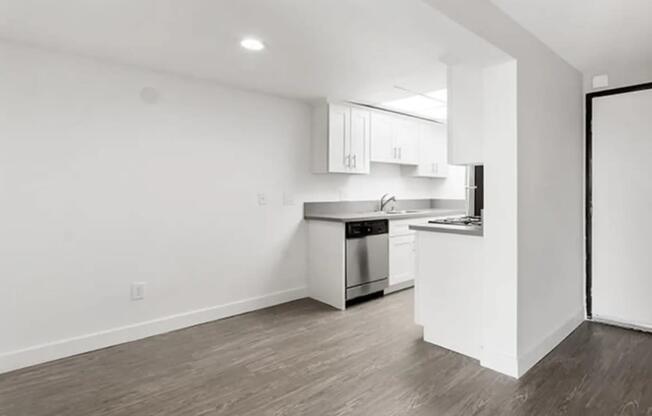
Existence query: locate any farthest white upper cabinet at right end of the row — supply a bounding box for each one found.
[404,122,448,178]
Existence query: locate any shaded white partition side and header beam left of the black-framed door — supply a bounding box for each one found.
[428,0,584,375]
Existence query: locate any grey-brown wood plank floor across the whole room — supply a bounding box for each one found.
[0,291,652,416]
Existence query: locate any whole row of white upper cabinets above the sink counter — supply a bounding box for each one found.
[312,102,448,178]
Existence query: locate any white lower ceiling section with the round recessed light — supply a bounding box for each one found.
[0,0,503,103]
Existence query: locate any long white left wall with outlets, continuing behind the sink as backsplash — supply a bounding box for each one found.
[0,43,464,372]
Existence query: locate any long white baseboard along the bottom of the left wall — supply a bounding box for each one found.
[0,287,307,373]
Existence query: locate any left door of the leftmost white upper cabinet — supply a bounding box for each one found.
[328,105,352,173]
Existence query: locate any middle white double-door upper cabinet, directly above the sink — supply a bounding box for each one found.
[371,111,419,165]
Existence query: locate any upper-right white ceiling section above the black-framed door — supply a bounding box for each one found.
[492,0,652,85]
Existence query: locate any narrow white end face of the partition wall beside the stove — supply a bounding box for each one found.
[478,60,518,375]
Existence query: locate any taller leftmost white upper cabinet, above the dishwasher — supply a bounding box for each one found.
[312,103,371,174]
